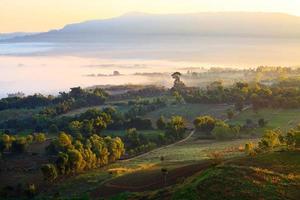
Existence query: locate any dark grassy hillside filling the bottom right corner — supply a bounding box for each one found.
[126,151,300,200]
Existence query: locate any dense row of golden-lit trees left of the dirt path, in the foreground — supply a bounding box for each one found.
[41,132,125,181]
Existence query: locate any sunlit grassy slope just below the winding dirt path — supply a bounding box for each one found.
[39,139,255,197]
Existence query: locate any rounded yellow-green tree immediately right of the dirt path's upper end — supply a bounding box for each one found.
[194,116,216,134]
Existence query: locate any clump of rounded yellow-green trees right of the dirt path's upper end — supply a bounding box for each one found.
[194,116,241,140]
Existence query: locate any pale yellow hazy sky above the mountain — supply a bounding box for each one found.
[0,0,300,32]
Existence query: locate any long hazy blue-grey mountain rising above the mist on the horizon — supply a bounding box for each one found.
[3,12,300,42]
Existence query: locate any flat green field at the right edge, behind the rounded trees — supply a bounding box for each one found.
[229,109,300,131]
